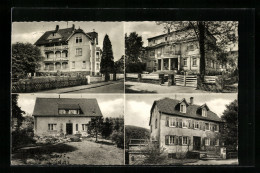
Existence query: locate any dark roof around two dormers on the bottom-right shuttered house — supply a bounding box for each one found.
[149,98,222,124]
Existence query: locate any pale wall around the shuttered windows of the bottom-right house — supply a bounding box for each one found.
[151,113,219,153]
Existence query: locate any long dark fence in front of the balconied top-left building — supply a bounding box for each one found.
[12,78,88,93]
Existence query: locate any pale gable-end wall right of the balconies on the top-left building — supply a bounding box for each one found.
[68,33,92,71]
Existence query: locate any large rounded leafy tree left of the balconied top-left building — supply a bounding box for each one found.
[12,42,43,78]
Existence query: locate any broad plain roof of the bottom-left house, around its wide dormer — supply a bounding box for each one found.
[33,98,102,117]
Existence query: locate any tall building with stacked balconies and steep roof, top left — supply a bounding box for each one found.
[35,24,101,75]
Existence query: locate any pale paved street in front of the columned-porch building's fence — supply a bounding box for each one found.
[125,81,207,93]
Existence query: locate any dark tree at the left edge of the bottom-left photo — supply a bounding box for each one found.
[12,94,25,130]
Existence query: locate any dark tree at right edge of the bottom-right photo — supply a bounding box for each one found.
[221,99,238,149]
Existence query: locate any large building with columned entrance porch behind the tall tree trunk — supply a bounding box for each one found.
[146,28,224,73]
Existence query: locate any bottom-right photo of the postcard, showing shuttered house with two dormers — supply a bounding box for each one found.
[125,93,239,165]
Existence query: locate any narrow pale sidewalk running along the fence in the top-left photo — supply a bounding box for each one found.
[38,80,123,94]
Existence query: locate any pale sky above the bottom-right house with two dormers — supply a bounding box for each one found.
[125,93,237,129]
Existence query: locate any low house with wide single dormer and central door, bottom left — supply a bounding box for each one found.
[33,98,103,136]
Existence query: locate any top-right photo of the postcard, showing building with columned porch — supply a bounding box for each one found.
[125,21,239,94]
